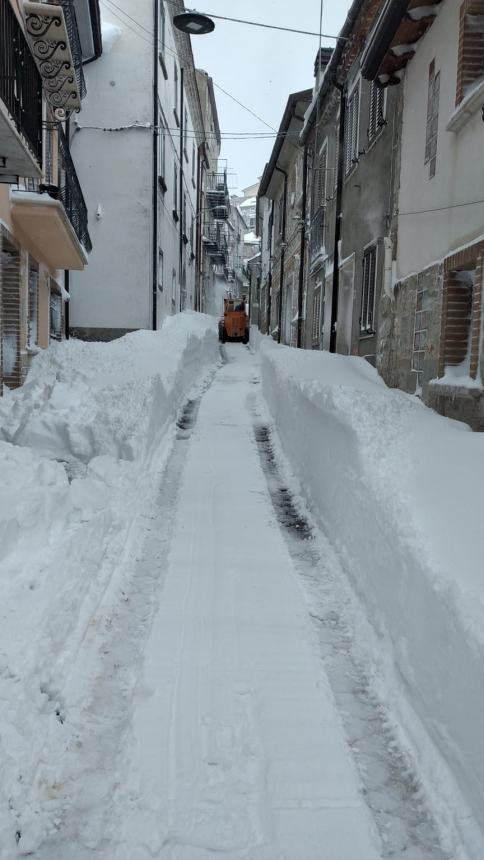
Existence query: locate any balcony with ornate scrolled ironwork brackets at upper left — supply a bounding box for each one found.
[23,0,86,121]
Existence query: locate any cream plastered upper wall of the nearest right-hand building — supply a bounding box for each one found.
[397,0,484,278]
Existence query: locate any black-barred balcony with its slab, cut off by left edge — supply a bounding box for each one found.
[0,0,42,182]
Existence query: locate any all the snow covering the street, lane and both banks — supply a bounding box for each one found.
[0,320,484,860]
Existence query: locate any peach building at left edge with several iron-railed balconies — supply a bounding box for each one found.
[0,0,102,390]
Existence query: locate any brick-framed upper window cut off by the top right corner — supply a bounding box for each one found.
[455,0,484,105]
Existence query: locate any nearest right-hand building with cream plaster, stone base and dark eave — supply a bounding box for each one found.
[362,0,484,430]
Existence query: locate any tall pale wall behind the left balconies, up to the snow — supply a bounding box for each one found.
[70,0,197,329]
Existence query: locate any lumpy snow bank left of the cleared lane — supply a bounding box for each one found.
[0,313,218,860]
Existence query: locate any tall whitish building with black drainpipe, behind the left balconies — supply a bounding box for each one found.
[71,0,218,339]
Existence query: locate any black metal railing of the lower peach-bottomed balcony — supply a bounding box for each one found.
[43,124,92,251]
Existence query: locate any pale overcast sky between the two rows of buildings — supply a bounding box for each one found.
[191,0,351,193]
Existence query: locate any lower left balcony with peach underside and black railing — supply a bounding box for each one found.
[10,126,92,270]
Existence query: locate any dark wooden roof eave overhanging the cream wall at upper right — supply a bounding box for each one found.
[361,0,441,86]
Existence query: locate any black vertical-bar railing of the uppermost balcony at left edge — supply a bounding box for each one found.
[0,0,42,164]
